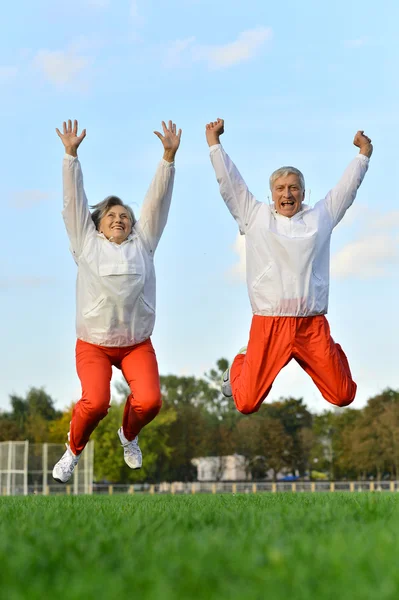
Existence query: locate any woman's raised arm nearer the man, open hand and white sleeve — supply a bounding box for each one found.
[137,121,182,253]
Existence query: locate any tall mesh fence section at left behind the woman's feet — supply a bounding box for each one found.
[0,441,94,496]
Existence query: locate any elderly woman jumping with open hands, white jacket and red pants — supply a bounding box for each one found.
[53,121,181,483]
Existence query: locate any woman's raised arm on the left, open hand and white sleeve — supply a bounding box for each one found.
[56,120,95,259]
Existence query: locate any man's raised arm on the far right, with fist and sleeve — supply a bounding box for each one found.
[323,131,373,227]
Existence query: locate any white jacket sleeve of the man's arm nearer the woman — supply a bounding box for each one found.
[210,144,262,235]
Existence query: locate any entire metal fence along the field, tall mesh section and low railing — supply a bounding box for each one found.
[0,442,399,496]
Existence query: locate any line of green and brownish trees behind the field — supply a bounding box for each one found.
[0,359,399,483]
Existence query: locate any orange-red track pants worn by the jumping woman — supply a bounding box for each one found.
[69,339,162,454]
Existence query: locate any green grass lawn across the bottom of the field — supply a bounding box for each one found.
[0,493,399,600]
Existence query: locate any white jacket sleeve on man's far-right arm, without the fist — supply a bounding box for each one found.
[322,154,369,227]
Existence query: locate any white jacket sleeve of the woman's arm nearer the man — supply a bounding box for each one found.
[136,159,175,253]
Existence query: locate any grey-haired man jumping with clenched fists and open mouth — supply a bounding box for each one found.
[206,119,373,414]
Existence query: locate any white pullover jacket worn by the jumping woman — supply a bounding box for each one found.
[62,154,175,346]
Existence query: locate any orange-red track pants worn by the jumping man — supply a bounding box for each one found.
[230,315,357,414]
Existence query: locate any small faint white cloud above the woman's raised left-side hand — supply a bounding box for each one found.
[33,48,93,88]
